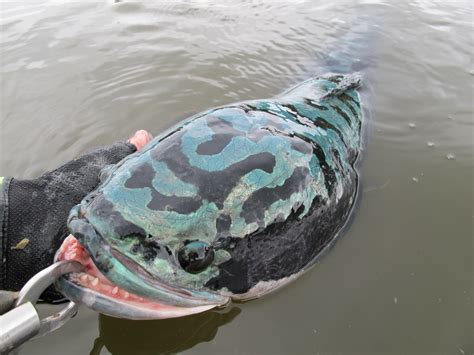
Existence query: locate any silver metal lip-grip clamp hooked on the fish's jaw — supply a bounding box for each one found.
[0,260,84,353]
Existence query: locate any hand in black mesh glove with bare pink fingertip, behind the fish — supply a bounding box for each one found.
[0,130,151,301]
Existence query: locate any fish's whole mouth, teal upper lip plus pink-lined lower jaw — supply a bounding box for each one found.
[55,206,230,319]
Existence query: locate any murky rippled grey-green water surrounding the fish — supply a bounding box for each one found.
[0,0,474,355]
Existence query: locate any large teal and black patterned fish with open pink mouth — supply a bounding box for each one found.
[56,73,364,319]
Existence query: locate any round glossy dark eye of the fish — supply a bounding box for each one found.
[178,240,214,274]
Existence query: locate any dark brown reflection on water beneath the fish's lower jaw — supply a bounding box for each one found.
[91,307,241,355]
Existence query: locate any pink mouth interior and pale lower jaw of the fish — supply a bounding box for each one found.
[55,235,228,320]
